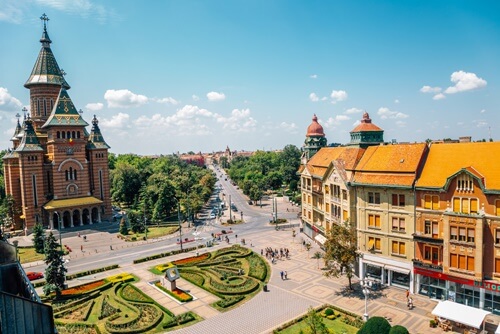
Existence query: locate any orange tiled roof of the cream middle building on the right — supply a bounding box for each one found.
[356,143,427,173]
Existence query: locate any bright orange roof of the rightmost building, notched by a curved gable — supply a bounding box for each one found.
[417,142,500,190]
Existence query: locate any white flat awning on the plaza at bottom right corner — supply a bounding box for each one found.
[432,300,491,329]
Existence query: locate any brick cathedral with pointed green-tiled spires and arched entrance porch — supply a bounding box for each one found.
[3,14,111,233]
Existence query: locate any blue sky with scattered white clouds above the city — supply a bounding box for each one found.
[0,0,500,154]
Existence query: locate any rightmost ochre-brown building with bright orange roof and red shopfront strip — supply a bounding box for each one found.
[413,142,500,314]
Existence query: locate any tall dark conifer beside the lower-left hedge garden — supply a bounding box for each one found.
[43,232,67,298]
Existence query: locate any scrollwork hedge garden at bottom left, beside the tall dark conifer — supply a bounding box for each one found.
[52,274,198,334]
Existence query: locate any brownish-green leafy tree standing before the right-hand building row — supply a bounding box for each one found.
[323,221,359,290]
